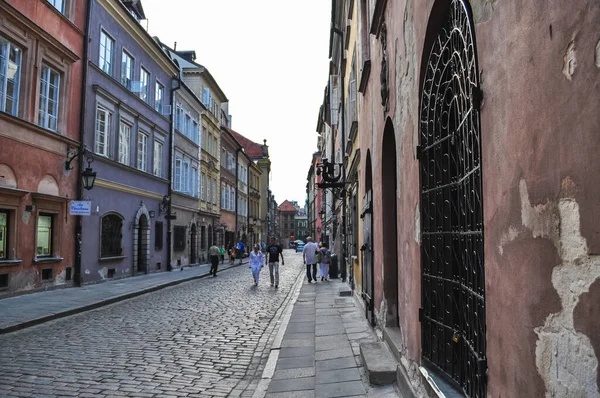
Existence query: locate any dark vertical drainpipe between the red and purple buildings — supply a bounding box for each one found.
[73,0,92,286]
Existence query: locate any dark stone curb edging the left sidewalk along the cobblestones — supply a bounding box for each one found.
[0,260,247,335]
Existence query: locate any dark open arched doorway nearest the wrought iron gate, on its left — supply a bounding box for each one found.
[381,119,399,327]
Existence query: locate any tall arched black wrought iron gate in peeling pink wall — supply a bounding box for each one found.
[418,0,487,397]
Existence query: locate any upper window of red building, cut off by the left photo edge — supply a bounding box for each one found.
[0,37,23,116]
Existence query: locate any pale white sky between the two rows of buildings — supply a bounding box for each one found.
[142,0,331,204]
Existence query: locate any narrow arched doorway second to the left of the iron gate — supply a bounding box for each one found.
[360,152,376,326]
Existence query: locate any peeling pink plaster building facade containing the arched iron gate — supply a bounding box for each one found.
[320,0,600,397]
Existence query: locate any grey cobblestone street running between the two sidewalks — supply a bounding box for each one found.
[0,250,303,397]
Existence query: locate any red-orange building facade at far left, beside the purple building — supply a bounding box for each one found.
[0,0,87,295]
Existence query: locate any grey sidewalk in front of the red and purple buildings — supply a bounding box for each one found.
[0,259,248,334]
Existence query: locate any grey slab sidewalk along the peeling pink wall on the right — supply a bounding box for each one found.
[253,280,400,398]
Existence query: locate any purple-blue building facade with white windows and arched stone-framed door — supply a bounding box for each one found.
[82,0,178,282]
